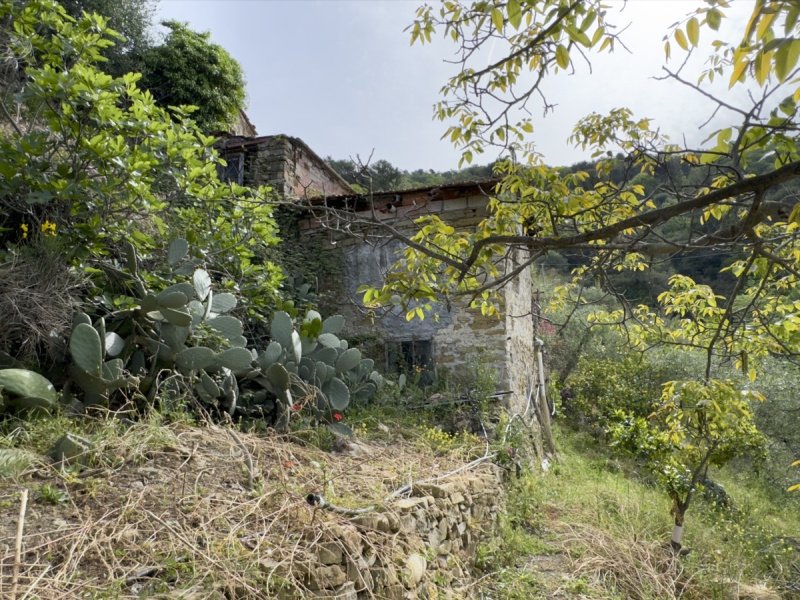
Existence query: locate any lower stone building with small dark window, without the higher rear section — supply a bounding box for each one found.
[301,181,536,422]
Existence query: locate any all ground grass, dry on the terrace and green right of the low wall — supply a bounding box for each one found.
[0,404,800,600]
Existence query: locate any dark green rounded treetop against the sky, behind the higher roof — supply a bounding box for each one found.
[142,21,245,132]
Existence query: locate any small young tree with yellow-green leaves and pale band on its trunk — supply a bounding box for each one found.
[611,380,764,551]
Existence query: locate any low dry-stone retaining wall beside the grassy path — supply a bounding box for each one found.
[276,464,503,600]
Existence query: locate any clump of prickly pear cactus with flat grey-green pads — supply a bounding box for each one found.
[57,239,383,429]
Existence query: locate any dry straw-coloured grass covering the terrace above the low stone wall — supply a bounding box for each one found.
[0,424,476,600]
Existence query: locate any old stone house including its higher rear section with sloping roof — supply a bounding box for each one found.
[221,135,536,420]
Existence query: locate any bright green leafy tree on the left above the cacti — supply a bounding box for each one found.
[0,0,281,340]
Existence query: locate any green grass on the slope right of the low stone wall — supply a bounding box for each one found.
[479,430,800,600]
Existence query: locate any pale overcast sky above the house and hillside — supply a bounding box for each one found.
[153,0,751,170]
